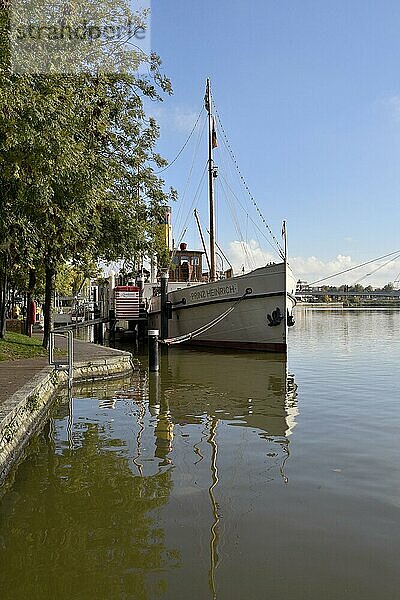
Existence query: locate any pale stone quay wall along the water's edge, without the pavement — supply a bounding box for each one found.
[0,350,133,484]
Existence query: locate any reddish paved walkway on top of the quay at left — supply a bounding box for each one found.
[0,336,130,404]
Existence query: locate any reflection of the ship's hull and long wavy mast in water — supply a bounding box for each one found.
[144,349,298,599]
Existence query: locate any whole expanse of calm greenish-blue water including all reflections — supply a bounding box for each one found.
[0,309,400,600]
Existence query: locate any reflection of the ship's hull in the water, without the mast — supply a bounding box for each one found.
[149,348,298,472]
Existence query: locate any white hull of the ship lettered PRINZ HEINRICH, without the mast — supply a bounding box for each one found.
[149,262,295,352]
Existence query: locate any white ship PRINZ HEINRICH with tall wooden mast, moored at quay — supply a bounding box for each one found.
[149,80,296,352]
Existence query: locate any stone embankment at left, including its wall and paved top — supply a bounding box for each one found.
[0,336,133,483]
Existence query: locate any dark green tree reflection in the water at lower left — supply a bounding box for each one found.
[0,396,180,600]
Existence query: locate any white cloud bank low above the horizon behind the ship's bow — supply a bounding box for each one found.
[227,240,400,287]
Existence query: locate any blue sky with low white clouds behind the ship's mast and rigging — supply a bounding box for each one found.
[142,0,400,285]
